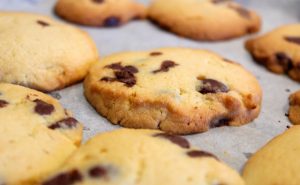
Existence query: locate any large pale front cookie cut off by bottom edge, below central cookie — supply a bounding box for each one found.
[42,129,244,185]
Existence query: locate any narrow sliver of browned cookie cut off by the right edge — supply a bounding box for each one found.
[288,91,300,125]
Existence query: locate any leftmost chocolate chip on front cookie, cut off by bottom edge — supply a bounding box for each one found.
[42,170,83,185]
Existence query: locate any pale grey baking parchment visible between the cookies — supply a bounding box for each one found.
[0,0,300,171]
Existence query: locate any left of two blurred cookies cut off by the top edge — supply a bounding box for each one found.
[55,0,146,27]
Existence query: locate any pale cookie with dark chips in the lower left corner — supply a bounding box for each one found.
[0,83,82,185]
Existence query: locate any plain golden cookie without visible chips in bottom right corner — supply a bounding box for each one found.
[243,126,300,185]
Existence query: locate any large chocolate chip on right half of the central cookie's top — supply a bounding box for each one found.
[198,79,229,94]
